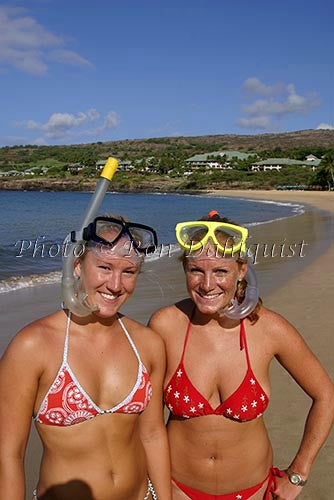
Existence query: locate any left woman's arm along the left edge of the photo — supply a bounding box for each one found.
[0,326,40,500]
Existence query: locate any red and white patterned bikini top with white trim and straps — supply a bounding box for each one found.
[34,314,152,427]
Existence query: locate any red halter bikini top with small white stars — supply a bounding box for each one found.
[164,320,269,422]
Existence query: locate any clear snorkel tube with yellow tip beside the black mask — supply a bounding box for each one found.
[61,157,118,316]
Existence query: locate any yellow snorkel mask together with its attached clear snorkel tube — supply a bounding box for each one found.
[175,210,259,320]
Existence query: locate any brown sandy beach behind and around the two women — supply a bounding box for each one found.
[0,191,334,500]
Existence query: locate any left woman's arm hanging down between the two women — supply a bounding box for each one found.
[140,330,172,500]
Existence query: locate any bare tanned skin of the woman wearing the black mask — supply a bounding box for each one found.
[0,241,171,500]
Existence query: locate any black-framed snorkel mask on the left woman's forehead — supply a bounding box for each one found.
[83,217,158,254]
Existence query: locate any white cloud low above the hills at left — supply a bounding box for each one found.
[15,108,119,144]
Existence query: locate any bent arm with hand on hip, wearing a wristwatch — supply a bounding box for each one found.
[271,315,334,500]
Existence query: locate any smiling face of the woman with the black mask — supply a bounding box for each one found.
[75,238,142,318]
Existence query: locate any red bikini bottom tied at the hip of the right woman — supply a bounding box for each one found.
[173,467,284,500]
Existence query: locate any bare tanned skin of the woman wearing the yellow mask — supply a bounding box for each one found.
[150,258,334,500]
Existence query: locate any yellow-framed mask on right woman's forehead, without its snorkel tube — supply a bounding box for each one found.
[175,221,248,256]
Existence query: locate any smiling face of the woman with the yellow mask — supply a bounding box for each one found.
[184,246,247,315]
